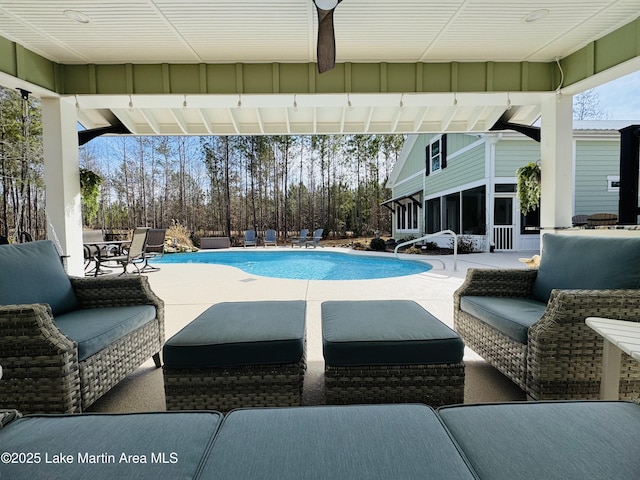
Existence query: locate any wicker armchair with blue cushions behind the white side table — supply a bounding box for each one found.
[454,234,640,400]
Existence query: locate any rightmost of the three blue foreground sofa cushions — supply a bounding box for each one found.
[438,401,640,480]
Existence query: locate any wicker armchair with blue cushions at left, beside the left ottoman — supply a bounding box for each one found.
[0,240,164,413]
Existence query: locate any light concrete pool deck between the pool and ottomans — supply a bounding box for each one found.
[149,247,527,361]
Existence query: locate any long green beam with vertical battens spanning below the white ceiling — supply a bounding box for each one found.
[58,62,556,95]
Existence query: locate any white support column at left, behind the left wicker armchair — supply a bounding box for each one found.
[42,98,84,276]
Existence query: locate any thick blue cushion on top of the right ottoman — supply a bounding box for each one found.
[322,300,464,366]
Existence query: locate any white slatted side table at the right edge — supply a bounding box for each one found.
[586,317,640,400]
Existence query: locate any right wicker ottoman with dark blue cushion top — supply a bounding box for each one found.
[322,300,464,406]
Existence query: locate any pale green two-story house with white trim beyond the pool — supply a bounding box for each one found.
[383,121,629,251]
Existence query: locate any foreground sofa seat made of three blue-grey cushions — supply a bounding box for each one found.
[0,401,640,480]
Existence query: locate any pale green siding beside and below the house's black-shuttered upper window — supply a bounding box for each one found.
[425,141,485,197]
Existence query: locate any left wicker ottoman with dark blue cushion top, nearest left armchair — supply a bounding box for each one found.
[163,301,306,412]
